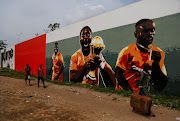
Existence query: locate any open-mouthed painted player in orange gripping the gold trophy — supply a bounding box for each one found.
[69,26,115,87]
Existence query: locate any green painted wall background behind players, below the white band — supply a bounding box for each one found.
[46,13,180,95]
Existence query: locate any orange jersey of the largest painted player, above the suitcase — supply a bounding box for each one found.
[116,43,167,92]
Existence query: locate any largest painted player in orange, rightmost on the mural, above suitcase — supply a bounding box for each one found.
[115,19,168,92]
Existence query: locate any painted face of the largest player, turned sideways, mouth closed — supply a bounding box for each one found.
[135,20,155,47]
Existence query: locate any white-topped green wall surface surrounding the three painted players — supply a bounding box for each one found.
[46,0,180,95]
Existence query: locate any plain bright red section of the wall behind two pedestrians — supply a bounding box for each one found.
[15,34,46,76]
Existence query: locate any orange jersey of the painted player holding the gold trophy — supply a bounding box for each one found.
[70,49,110,85]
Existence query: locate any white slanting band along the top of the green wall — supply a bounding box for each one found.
[46,0,180,43]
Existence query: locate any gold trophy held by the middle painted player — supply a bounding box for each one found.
[88,36,105,84]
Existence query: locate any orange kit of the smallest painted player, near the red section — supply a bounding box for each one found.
[52,52,63,82]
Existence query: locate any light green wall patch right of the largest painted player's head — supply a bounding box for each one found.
[154,13,180,50]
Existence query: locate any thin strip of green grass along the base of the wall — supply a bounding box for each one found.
[0,68,180,110]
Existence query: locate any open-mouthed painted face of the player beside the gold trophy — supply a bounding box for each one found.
[80,29,92,54]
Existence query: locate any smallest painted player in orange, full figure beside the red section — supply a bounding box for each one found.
[51,42,63,82]
